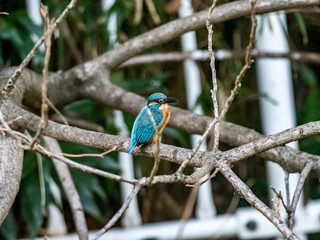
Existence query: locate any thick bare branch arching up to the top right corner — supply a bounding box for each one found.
[66,0,319,79]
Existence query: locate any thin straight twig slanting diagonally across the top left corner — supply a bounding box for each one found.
[2,0,77,96]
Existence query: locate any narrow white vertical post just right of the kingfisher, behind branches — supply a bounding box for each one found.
[179,0,216,218]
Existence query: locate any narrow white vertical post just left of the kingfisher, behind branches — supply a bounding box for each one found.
[102,0,142,227]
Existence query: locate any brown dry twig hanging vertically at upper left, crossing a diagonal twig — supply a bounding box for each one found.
[30,3,53,149]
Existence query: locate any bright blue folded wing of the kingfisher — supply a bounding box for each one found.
[132,107,162,143]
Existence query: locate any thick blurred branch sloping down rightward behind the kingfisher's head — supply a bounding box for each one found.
[80,79,320,172]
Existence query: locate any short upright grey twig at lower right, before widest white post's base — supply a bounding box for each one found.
[288,161,313,230]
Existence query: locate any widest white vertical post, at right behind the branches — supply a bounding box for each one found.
[256,12,303,237]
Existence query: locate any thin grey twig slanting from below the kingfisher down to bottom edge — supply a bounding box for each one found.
[92,178,145,240]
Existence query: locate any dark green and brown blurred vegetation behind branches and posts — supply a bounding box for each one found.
[0,0,320,239]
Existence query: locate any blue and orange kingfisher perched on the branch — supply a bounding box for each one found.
[128,93,178,154]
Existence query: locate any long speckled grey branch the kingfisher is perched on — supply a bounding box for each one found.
[5,100,320,174]
